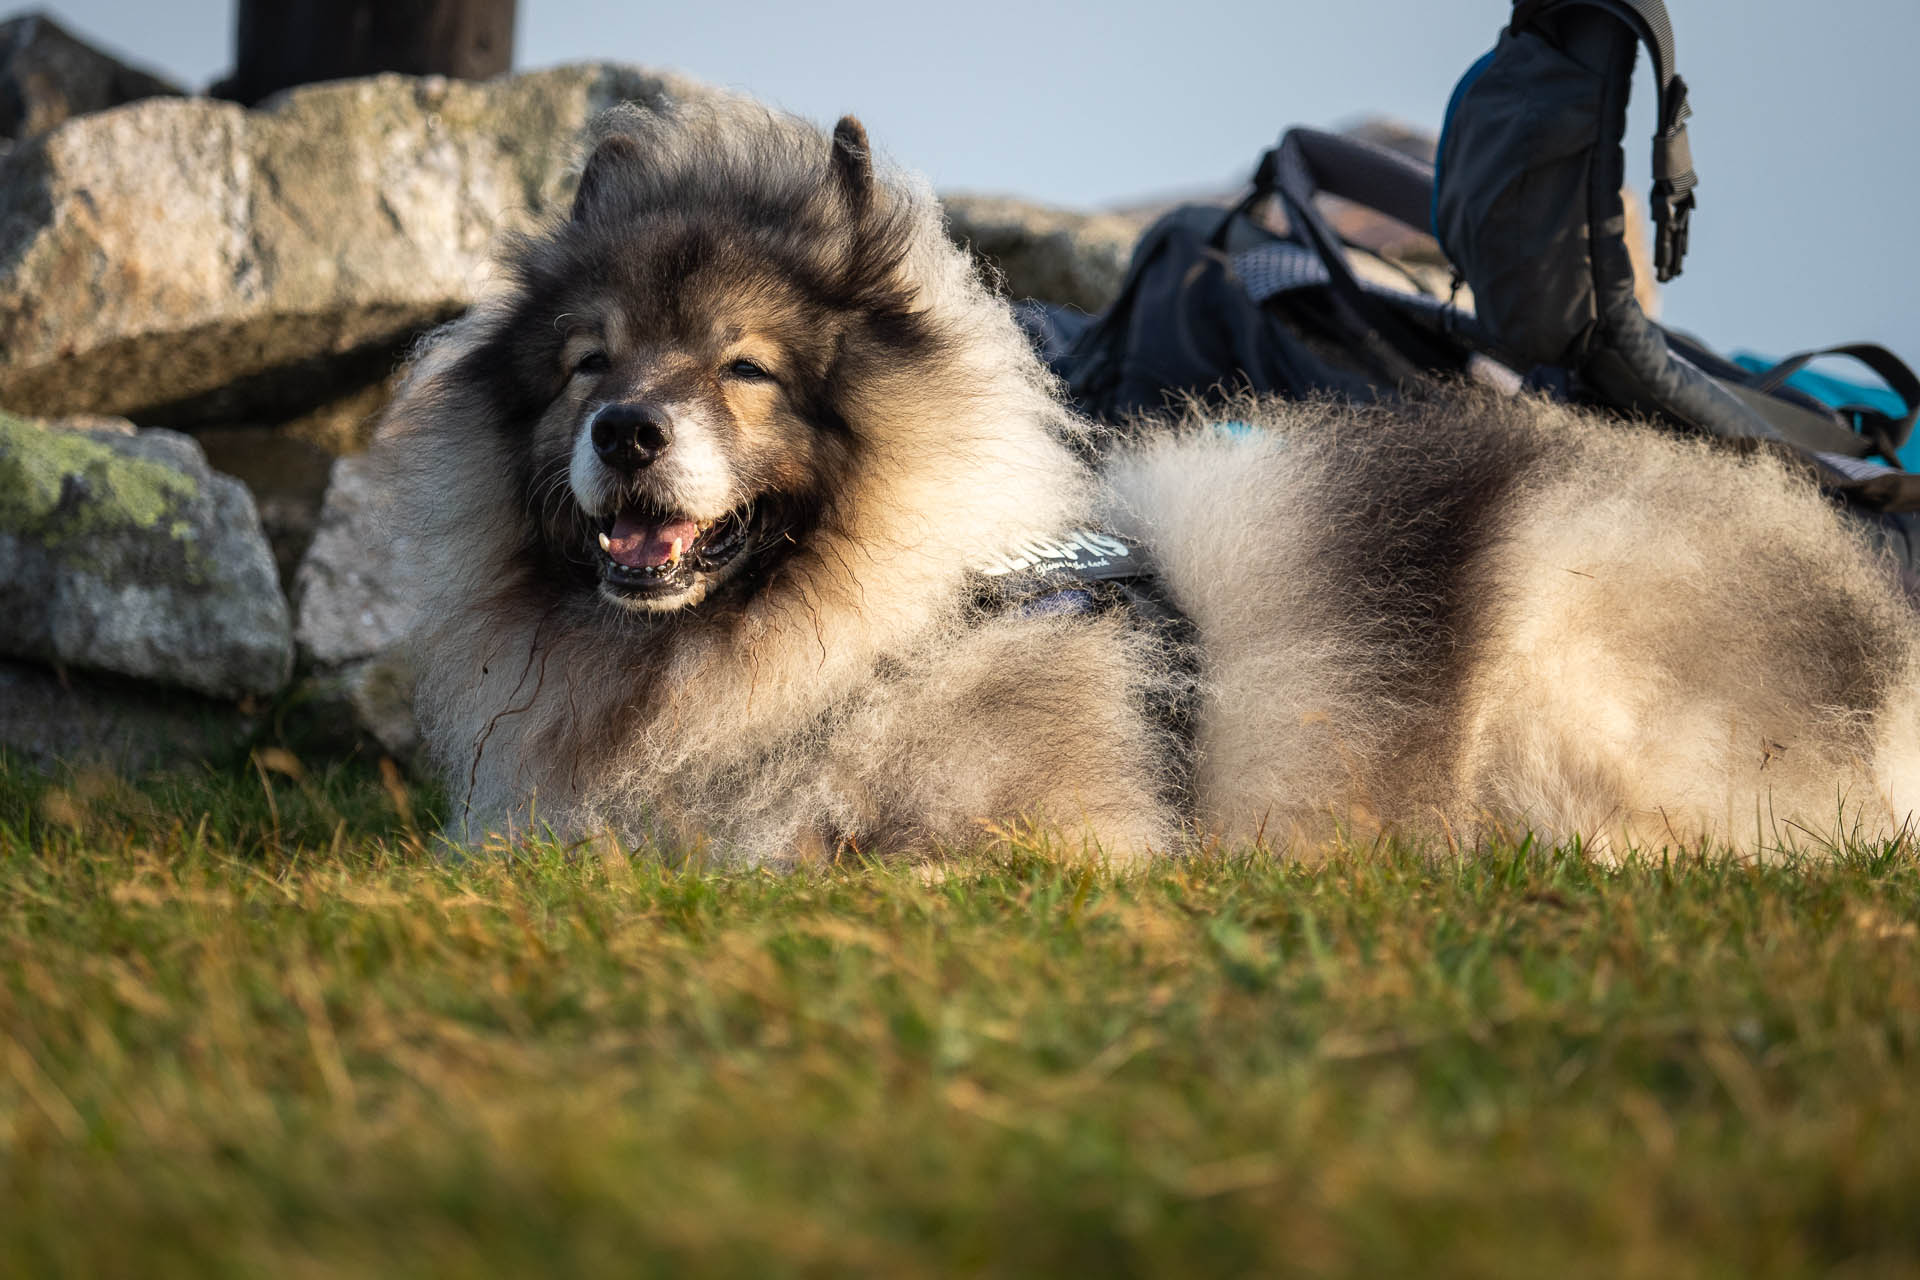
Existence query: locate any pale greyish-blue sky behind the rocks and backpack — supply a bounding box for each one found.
[26,0,1920,365]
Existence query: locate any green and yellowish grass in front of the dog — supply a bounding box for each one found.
[0,752,1920,1278]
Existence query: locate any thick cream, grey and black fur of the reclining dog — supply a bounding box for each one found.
[382,100,1920,862]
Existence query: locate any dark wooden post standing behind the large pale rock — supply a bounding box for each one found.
[215,0,516,104]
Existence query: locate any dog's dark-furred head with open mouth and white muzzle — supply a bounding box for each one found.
[449,117,935,612]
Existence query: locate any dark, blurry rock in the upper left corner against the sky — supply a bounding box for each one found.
[0,13,184,138]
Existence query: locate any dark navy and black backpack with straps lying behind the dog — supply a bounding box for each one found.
[1023,0,1920,568]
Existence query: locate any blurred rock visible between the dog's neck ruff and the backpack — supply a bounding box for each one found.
[943,196,1142,311]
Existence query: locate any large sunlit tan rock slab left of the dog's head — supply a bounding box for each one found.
[0,65,707,426]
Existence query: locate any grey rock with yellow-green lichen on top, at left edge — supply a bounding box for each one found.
[0,415,294,700]
